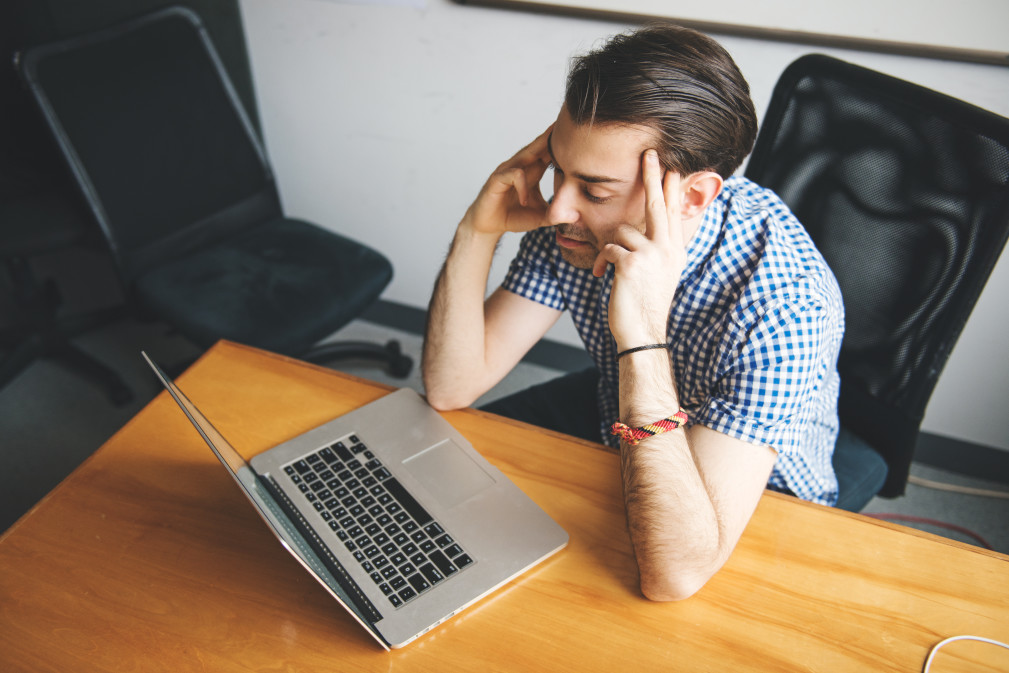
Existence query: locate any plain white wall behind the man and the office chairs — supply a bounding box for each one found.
[241,0,1009,450]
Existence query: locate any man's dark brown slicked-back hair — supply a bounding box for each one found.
[564,24,757,178]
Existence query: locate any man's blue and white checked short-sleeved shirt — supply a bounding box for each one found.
[502,177,845,504]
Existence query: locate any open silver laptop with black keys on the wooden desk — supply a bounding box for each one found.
[143,353,568,650]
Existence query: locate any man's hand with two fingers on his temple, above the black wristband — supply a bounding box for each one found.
[592,149,687,350]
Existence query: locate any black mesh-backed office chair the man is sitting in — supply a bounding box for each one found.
[746,54,1009,512]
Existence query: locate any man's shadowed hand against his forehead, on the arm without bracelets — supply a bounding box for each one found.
[460,124,553,235]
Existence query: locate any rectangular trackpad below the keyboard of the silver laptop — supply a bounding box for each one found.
[403,439,494,508]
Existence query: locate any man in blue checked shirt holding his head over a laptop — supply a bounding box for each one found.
[423,26,844,600]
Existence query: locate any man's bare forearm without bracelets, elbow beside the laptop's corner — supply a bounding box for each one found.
[422,220,500,409]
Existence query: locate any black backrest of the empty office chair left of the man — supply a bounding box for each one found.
[22,8,279,282]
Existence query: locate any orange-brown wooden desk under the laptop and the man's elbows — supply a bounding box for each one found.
[0,343,1009,673]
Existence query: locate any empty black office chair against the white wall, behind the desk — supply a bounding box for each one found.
[20,7,412,376]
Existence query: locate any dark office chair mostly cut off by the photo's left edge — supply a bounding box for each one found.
[0,2,133,405]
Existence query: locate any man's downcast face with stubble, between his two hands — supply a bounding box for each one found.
[547,108,656,268]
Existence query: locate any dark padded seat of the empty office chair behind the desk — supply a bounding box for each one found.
[136,218,393,356]
